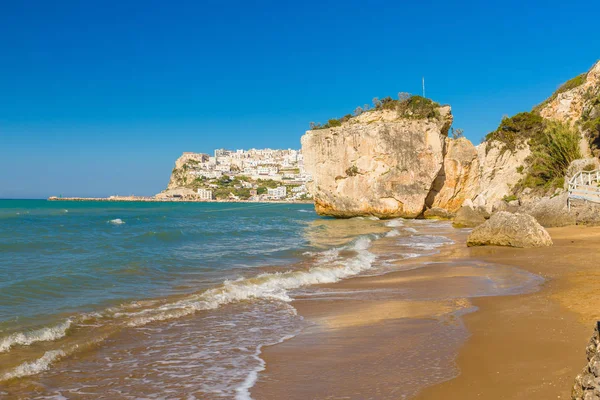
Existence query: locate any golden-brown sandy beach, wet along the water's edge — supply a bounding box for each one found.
[252,227,600,400]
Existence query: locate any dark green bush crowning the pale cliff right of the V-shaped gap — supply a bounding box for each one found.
[485,112,545,151]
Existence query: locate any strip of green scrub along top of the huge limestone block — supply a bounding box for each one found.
[310,92,440,130]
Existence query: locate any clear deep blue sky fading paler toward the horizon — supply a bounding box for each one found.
[0,0,600,198]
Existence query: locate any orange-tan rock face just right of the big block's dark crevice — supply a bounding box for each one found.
[431,138,479,212]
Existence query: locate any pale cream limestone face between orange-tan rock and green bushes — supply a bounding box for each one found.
[474,141,531,213]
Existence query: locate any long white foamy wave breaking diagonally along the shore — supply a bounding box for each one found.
[0,235,380,382]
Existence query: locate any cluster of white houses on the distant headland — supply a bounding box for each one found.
[183,149,312,200]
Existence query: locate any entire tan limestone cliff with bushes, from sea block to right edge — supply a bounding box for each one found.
[302,62,600,218]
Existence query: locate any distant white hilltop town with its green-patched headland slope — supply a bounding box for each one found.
[156,149,312,201]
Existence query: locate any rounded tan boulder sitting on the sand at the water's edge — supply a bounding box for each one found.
[467,211,552,247]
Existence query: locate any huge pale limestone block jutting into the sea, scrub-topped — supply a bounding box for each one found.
[302,106,452,218]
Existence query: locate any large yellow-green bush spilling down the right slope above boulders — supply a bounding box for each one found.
[520,122,581,188]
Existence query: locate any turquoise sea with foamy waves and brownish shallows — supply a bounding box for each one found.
[0,200,544,399]
